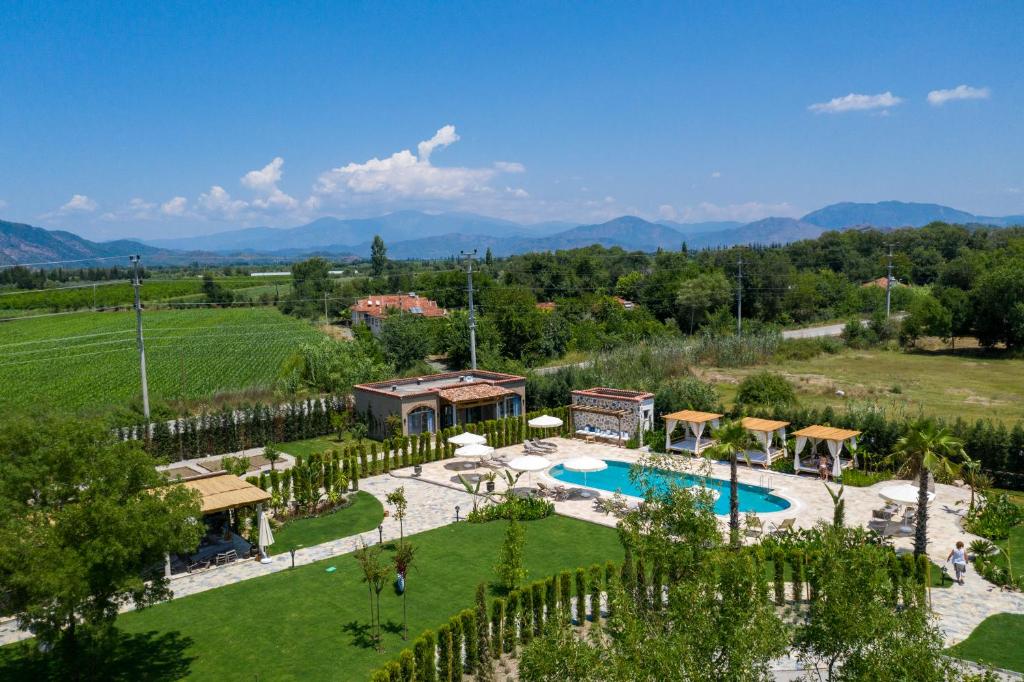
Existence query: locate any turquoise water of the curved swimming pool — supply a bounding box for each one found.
[548,460,790,514]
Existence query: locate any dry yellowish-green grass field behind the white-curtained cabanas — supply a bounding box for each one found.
[700,349,1024,423]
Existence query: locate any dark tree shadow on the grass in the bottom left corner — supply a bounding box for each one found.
[0,630,196,682]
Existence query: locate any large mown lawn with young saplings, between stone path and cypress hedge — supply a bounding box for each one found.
[0,516,623,681]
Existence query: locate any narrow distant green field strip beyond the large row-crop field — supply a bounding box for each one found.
[0,276,291,316]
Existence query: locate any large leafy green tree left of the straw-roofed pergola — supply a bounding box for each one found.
[0,417,202,665]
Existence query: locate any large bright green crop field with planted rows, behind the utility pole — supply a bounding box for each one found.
[0,308,321,412]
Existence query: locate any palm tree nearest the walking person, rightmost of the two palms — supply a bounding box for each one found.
[893,420,967,557]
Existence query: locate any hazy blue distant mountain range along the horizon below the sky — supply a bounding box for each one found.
[0,202,1024,264]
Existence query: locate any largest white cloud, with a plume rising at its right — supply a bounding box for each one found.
[314,125,498,200]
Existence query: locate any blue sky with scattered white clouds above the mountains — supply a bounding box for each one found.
[0,0,1024,239]
